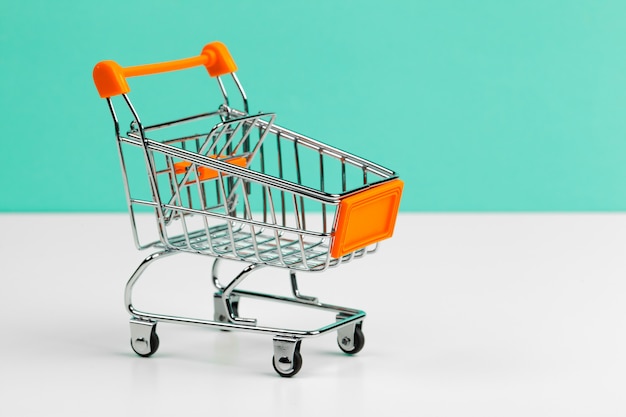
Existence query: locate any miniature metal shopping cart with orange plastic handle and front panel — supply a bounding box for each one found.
[93,42,402,377]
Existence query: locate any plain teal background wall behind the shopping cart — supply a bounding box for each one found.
[0,0,626,212]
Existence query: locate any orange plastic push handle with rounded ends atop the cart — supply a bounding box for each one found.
[93,42,237,98]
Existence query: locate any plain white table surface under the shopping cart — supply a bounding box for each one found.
[0,214,626,417]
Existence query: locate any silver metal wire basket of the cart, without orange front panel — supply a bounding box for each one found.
[103,76,397,271]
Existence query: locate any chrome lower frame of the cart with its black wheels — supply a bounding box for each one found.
[124,249,365,377]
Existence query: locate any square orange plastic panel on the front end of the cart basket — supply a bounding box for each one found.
[330,179,404,258]
